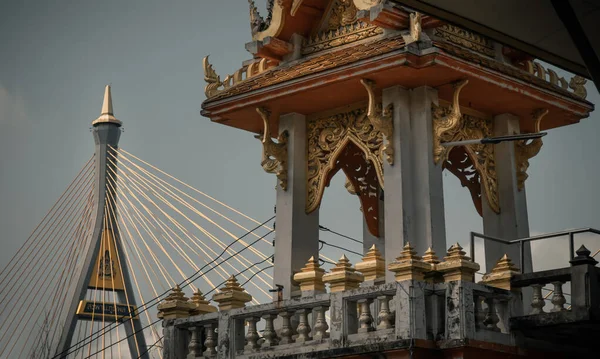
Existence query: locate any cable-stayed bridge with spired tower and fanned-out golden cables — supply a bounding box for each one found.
[0,86,362,358]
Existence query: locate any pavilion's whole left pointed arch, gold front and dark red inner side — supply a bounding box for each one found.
[306,108,384,236]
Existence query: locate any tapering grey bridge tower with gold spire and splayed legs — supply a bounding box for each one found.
[57,85,148,359]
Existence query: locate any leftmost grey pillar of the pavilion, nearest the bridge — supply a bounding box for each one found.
[273,113,319,300]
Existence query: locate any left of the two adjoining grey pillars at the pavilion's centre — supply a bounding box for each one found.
[378,86,414,283]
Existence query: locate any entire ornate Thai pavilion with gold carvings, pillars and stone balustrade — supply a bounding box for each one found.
[159,0,600,359]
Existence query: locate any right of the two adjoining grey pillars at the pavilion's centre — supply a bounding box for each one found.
[407,86,446,256]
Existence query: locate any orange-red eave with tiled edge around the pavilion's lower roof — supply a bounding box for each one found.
[202,46,594,134]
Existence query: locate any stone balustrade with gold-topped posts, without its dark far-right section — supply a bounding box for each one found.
[161,244,522,359]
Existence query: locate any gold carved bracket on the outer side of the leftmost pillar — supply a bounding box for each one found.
[254,107,288,191]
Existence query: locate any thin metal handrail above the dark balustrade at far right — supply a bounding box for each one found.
[469,228,600,273]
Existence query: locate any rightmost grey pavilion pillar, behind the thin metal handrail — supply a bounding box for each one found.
[482,114,532,273]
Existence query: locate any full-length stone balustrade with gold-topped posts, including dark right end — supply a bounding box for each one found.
[159,244,600,359]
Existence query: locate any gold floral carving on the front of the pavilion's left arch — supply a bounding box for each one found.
[306,108,383,213]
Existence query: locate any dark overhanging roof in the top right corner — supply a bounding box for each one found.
[392,0,600,91]
